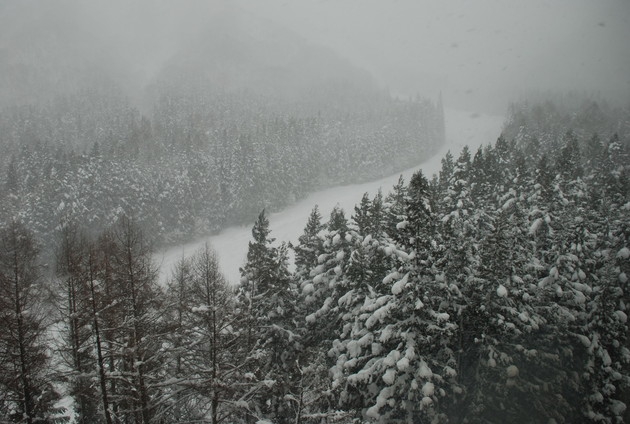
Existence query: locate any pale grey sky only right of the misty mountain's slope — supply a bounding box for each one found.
[239,0,630,111]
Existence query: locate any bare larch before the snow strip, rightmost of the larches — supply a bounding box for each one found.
[168,245,248,423]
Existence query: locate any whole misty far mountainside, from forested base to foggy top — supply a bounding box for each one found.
[0,0,444,250]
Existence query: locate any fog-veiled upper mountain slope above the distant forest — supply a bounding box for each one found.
[0,1,376,110]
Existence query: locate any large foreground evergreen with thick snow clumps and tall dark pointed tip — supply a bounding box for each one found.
[331,173,456,422]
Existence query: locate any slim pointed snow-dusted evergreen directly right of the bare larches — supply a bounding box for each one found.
[239,210,300,422]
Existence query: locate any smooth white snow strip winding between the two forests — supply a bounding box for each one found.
[155,109,503,283]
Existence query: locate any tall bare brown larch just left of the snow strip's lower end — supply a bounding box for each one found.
[109,217,164,424]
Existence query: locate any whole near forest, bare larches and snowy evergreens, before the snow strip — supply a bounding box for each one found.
[0,98,630,423]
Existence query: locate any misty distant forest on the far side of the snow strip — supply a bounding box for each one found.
[0,84,444,252]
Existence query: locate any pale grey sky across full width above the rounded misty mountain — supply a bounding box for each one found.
[0,0,630,113]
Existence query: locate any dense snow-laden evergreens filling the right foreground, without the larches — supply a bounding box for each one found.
[296,101,630,422]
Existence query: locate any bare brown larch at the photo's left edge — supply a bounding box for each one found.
[0,221,62,424]
